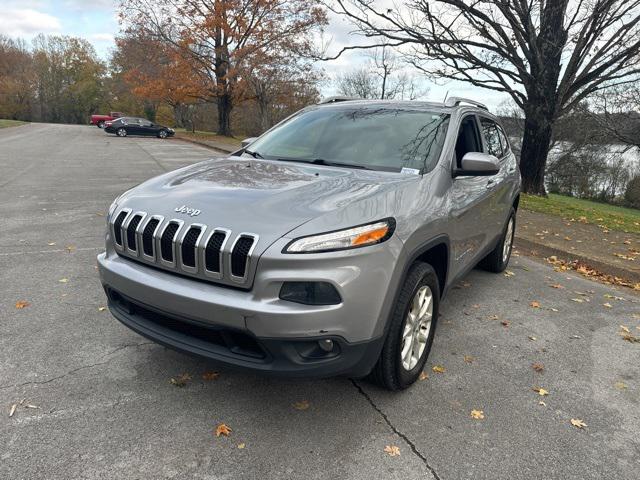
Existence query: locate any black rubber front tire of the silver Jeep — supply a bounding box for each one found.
[369,262,440,390]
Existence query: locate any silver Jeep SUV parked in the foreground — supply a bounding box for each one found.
[98,98,520,390]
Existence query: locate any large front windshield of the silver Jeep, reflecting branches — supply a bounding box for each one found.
[242,105,449,171]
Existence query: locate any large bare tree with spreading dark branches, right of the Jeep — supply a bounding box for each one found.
[326,0,640,194]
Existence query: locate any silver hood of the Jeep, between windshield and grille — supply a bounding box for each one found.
[118,157,419,254]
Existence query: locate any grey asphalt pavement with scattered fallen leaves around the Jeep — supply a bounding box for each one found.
[0,124,640,480]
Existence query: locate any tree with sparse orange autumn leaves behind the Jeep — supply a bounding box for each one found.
[119,0,327,135]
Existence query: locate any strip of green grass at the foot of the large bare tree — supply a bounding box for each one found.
[520,193,640,234]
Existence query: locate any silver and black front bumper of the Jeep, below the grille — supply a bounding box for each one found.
[98,240,396,377]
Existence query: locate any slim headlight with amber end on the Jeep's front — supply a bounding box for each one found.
[284,218,396,253]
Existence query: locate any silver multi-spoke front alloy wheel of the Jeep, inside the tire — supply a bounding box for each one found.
[400,285,433,371]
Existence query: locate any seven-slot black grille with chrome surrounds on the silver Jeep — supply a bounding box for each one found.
[109,209,258,286]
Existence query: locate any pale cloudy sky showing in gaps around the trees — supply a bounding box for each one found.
[0,0,507,111]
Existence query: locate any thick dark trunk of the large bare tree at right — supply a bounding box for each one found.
[520,111,553,195]
